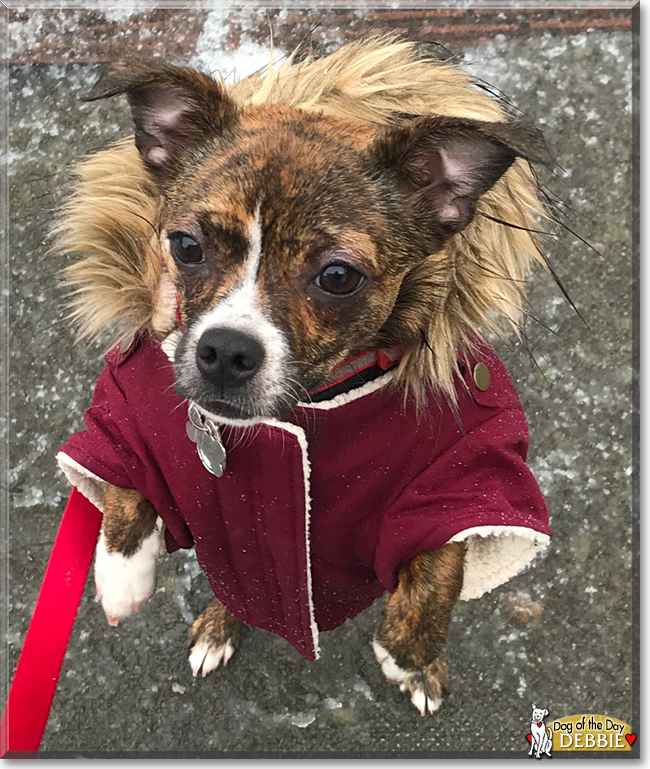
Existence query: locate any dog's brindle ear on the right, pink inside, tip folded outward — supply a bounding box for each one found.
[366,116,553,239]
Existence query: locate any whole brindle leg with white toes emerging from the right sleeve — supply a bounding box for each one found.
[373,542,466,715]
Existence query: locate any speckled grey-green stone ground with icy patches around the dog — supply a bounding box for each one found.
[2,9,639,755]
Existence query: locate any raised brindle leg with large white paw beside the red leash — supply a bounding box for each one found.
[95,485,162,627]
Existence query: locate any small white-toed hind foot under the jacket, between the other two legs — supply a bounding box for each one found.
[187,599,243,678]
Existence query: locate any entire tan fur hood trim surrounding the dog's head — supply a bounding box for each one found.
[55,35,546,399]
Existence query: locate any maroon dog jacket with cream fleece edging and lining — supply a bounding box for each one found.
[59,337,551,659]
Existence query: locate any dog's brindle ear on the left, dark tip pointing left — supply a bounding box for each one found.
[84,61,237,183]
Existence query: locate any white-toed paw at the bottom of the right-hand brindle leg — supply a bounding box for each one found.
[372,641,451,716]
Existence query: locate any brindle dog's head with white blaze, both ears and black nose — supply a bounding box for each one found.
[89,63,546,419]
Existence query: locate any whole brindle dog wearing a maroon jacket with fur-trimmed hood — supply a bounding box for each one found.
[55,36,551,715]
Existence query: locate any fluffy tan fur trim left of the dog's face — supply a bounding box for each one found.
[52,137,174,346]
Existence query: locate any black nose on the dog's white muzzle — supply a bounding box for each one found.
[196,328,264,394]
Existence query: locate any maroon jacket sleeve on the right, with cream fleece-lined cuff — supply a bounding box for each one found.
[375,409,551,599]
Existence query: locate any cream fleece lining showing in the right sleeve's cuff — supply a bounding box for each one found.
[449,526,550,601]
